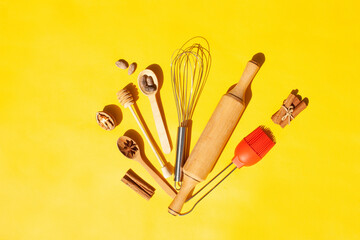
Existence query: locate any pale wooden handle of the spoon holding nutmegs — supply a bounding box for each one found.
[149,95,171,154]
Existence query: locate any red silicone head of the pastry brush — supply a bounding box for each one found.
[232,126,275,168]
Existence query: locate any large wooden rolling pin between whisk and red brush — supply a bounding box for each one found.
[168,54,264,216]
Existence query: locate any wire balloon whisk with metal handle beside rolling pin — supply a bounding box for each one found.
[170,37,211,189]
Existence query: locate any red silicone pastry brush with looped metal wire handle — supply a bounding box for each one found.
[179,126,275,216]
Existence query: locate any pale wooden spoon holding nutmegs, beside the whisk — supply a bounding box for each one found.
[138,69,171,154]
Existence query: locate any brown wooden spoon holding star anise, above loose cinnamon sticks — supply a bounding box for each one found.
[117,136,177,198]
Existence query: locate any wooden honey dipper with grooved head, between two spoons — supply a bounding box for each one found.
[116,88,171,178]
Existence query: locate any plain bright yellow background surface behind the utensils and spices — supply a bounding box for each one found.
[0,0,360,240]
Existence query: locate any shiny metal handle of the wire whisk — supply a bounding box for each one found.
[174,127,187,183]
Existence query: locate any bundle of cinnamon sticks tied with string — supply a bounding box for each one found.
[271,90,308,128]
